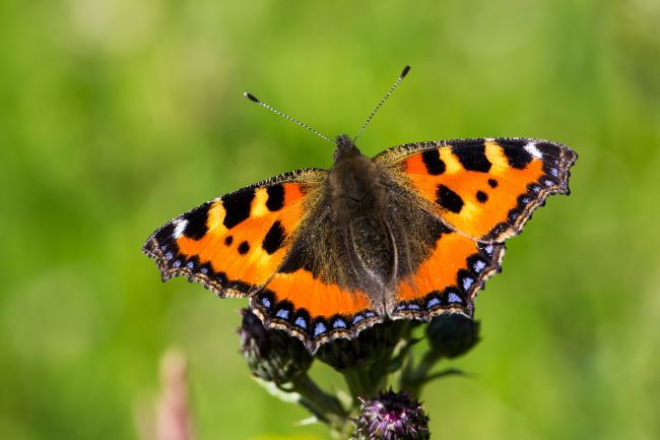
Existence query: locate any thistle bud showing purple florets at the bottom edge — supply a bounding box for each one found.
[354,390,430,440]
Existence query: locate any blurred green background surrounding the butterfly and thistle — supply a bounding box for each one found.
[0,0,660,440]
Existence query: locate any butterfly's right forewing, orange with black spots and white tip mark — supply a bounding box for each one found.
[376,139,577,242]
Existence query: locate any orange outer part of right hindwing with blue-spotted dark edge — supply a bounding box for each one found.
[390,231,505,320]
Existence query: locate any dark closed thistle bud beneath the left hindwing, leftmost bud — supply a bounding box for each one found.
[238,308,312,385]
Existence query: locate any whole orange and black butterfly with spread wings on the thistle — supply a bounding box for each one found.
[144,68,577,352]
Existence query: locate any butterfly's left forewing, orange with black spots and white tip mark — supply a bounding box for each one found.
[143,170,327,296]
